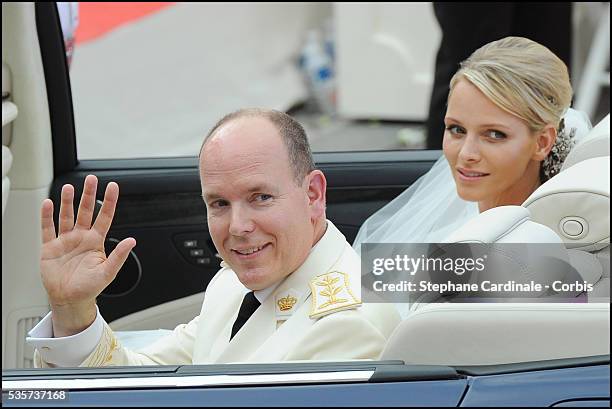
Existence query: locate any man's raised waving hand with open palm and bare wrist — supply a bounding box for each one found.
[40,175,136,337]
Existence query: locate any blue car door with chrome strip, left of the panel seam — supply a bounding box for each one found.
[3,361,468,407]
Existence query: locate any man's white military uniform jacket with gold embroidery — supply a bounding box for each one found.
[35,221,399,367]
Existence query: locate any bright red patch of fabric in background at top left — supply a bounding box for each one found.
[75,2,174,44]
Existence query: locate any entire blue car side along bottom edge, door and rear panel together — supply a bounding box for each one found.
[2,355,610,407]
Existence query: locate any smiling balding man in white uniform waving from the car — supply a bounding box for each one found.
[29,110,399,366]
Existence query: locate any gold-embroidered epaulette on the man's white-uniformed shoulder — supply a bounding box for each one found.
[310,271,361,318]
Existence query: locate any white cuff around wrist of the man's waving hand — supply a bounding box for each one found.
[26,305,104,367]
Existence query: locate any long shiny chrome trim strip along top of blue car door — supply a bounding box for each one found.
[2,371,374,391]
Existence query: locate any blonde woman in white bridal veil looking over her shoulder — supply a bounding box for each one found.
[353,37,591,252]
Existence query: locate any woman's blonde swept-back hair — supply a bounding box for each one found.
[449,37,572,132]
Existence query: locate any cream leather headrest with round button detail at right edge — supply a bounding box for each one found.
[523,156,610,250]
